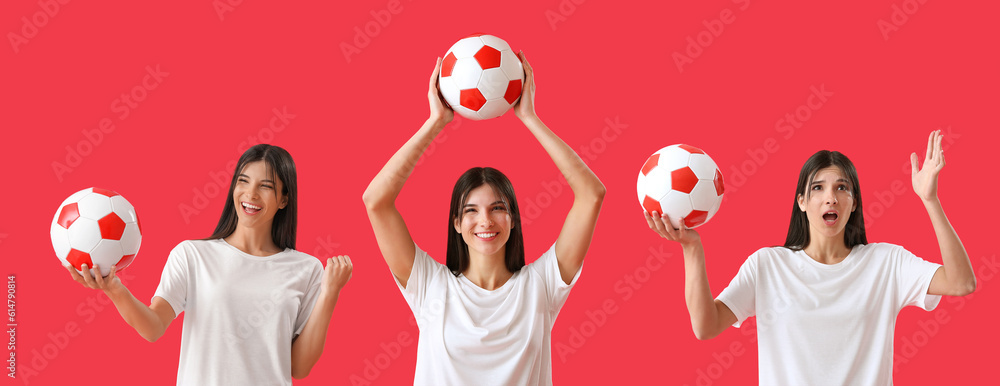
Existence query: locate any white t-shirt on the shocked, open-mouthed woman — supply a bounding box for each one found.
[718,243,941,385]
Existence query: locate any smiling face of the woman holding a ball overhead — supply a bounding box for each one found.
[455,184,514,256]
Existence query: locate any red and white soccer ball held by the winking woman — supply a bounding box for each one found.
[49,188,142,276]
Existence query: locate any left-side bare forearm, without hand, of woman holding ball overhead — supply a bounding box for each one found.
[363,119,445,208]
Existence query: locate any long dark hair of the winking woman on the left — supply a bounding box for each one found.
[205,143,299,250]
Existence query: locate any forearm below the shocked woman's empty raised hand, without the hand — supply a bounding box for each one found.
[923,198,976,295]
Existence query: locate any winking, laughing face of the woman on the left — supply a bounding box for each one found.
[233,161,288,231]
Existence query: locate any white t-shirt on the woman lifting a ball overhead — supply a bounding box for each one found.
[393,245,582,385]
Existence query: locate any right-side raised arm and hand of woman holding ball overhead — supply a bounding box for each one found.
[514,53,606,284]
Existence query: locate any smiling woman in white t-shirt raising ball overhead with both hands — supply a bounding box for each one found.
[364,54,605,385]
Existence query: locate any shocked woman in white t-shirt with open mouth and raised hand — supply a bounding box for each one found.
[646,131,976,385]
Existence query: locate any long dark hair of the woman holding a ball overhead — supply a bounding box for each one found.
[447,167,524,276]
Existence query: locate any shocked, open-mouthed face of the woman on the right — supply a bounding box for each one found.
[798,166,858,237]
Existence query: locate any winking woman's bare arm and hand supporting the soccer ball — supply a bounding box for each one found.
[66,264,176,342]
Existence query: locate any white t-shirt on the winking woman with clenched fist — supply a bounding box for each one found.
[153,239,323,385]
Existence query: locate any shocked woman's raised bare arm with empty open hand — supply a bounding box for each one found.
[910,130,976,296]
